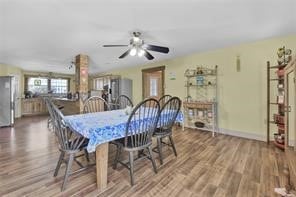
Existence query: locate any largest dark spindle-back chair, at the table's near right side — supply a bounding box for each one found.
[113,98,159,185]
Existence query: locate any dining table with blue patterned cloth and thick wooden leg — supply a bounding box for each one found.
[64,109,183,191]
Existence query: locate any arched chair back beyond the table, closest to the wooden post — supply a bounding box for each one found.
[83,96,110,113]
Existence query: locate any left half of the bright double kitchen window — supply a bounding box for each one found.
[28,77,48,93]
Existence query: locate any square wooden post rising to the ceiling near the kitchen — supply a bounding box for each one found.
[75,54,88,113]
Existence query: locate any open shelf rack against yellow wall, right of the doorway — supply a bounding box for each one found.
[183,66,218,136]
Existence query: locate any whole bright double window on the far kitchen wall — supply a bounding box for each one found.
[26,77,70,94]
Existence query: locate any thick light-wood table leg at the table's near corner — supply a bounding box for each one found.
[96,142,108,192]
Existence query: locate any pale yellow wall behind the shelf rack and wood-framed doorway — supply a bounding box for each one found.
[103,35,296,139]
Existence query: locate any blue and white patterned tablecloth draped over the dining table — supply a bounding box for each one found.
[65,110,183,152]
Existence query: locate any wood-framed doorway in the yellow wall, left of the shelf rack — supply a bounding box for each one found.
[142,66,165,100]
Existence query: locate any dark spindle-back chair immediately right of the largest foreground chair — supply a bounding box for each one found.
[153,97,181,164]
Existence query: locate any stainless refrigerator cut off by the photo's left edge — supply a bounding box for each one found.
[0,77,14,127]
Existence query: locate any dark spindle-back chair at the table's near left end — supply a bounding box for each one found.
[52,105,94,191]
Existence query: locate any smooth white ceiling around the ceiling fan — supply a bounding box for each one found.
[0,0,296,73]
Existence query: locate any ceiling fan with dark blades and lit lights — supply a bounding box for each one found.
[103,32,169,60]
